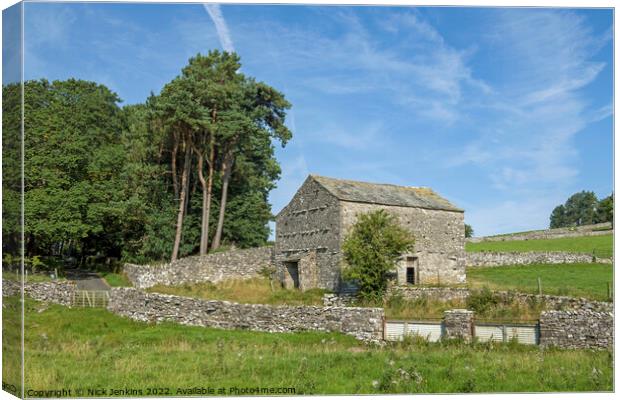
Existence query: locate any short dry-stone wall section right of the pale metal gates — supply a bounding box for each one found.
[540,310,614,349]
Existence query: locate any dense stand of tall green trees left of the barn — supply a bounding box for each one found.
[3,51,292,268]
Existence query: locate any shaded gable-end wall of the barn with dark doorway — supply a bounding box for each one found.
[274,179,340,290]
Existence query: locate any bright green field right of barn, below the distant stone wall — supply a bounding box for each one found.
[467,264,613,301]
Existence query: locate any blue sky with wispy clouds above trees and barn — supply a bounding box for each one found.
[12,3,613,235]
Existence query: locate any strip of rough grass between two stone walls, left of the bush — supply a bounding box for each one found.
[149,278,325,305]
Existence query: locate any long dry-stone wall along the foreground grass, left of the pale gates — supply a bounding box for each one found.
[108,288,384,340]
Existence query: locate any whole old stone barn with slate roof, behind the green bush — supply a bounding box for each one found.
[274,175,465,291]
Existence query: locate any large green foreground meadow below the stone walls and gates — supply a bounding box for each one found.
[3,298,613,397]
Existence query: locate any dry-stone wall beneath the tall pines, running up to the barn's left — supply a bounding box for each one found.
[124,246,273,289]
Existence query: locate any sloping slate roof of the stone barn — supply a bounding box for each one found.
[310,175,463,212]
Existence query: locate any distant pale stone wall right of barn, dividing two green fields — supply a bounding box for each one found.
[465,251,612,267]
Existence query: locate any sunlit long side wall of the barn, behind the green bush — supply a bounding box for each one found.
[341,201,465,284]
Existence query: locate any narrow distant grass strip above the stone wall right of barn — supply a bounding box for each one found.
[465,235,613,257]
